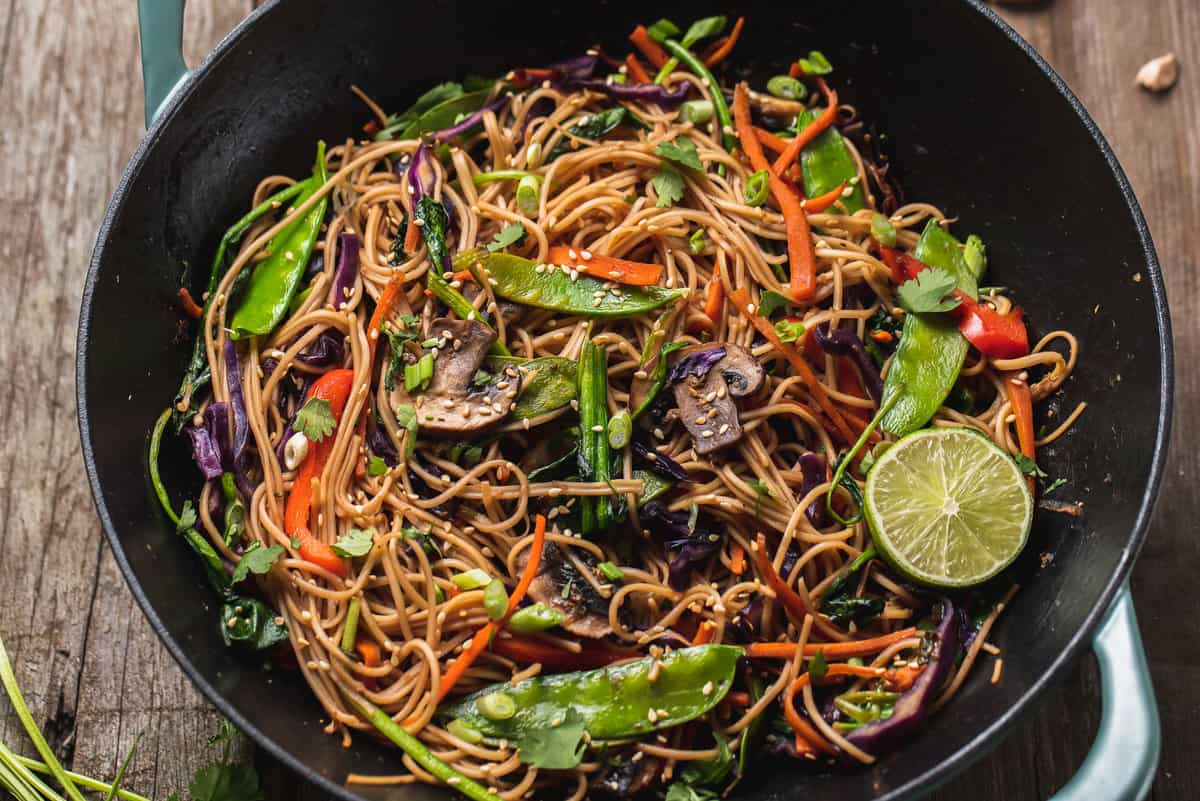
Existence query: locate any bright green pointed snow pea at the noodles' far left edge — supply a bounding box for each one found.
[229,141,329,339]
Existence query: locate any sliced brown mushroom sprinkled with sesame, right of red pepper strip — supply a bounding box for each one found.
[391,318,521,434]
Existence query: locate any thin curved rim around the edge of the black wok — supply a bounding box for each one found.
[76,0,1175,801]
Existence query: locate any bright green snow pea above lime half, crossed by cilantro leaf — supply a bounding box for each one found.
[880,219,978,436]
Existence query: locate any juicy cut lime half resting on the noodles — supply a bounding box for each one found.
[865,428,1033,589]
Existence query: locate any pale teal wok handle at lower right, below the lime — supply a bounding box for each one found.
[1050,582,1160,801]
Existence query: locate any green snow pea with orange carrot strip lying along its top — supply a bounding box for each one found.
[470,253,683,317]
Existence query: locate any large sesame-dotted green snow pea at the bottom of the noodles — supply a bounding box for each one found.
[438,645,743,740]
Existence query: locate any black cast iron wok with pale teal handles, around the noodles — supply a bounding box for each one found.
[77,0,1172,801]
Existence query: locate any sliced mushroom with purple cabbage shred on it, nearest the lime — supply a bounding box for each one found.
[674,343,766,456]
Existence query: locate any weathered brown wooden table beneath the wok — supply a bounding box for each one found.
[0,0,1200,801]
